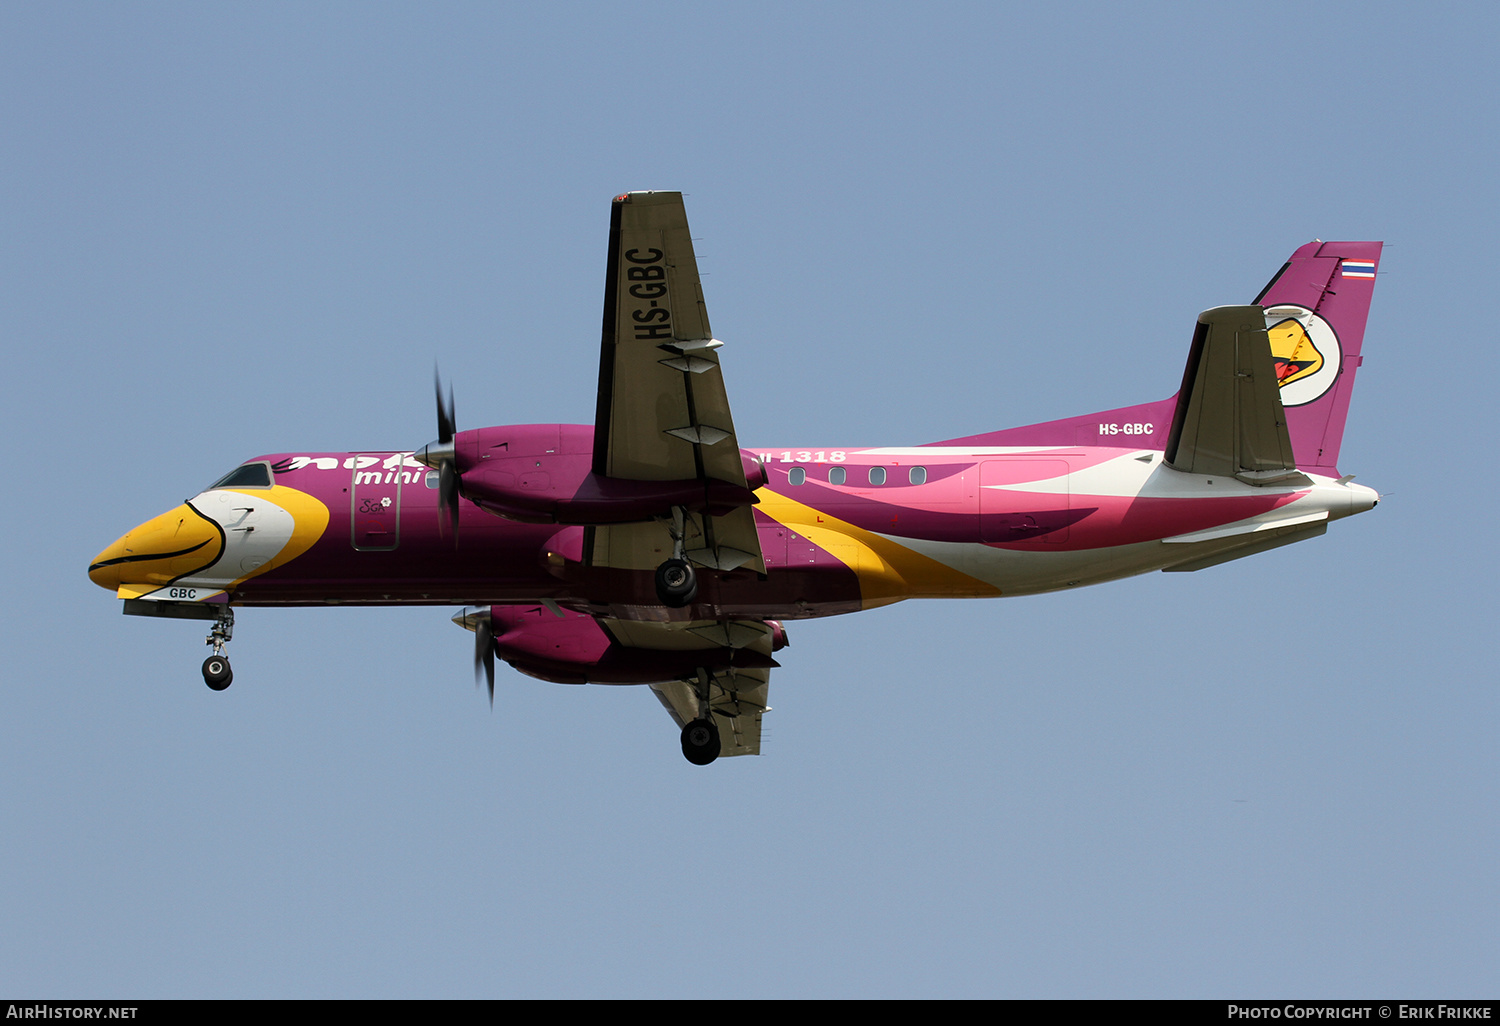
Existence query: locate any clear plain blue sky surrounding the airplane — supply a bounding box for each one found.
[0,3,1500,998]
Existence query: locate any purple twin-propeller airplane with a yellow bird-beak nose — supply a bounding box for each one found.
[89,192,1382,765]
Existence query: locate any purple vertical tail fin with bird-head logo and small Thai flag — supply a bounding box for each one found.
[1256,242,1382,474]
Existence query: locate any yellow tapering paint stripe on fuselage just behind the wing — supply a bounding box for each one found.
[756,488,1001,609]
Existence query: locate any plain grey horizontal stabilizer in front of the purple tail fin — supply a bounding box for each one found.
[1166,306,1307,485]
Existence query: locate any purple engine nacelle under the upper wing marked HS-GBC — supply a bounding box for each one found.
[453,425,767,525]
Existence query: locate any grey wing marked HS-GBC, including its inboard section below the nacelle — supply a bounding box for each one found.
[585,192,765,573]
